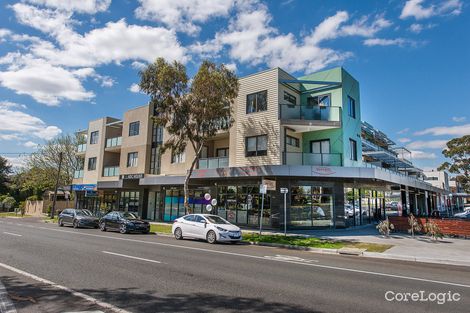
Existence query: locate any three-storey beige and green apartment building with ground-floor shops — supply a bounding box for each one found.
[73,68,446,228]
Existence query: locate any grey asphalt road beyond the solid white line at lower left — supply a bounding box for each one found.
[0,219,470,312]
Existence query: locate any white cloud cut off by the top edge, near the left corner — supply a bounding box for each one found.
[26,0,111,14]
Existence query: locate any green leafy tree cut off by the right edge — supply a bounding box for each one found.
[438,135,470,192]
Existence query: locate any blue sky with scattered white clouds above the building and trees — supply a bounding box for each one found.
[0,0,470,169]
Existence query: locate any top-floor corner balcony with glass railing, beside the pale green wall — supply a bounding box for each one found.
[279,103,341,132]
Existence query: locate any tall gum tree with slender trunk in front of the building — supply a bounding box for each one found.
[139,58,239,212]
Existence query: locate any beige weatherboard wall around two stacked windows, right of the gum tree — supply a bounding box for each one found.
[230,68,282,166]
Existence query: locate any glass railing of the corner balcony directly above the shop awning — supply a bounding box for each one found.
[284,152,343,166]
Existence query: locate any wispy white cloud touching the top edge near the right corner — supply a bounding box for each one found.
[400,0,463,20]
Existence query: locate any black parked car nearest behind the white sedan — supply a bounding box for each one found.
[100,211,150,234]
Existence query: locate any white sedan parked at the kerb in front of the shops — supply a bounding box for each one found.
[171,214,242,243]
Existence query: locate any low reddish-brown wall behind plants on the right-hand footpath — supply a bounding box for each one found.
[389,216,470,237]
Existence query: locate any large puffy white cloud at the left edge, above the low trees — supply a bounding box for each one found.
[0,57,94,106]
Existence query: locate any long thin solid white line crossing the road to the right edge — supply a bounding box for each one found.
[0,221,470,288]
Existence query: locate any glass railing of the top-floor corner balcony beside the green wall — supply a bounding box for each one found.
[279,104,341,122]
